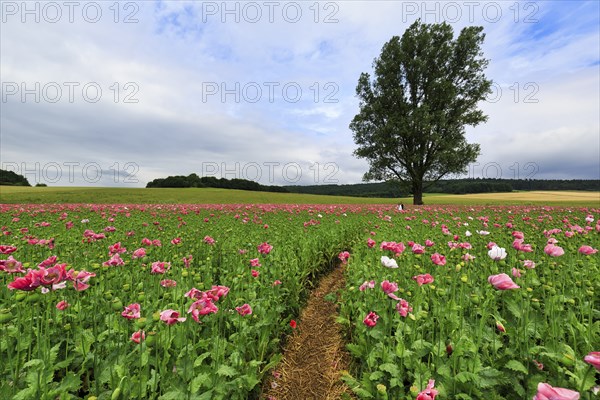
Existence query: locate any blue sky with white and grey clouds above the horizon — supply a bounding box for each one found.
[0,0,600,187]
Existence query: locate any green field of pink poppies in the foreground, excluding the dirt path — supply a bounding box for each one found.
[0,204,600,400]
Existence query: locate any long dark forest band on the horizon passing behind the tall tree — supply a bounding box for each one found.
[146,174,600,198]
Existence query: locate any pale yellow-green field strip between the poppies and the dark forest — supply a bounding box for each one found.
[0,186,600,207]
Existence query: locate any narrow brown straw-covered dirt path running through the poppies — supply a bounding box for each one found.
[264,266,351,400]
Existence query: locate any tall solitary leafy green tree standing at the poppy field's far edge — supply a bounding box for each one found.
[350,21,492,205]
